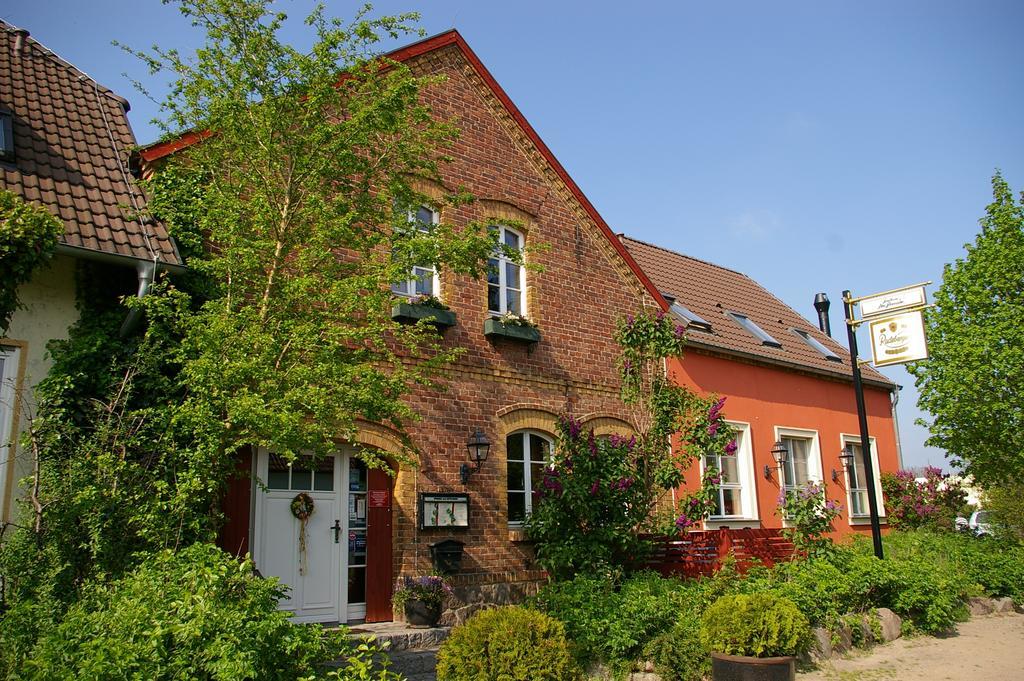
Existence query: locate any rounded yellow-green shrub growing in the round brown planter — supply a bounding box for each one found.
[700,593,811,657]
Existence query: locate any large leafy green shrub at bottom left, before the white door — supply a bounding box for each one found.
[20,544,398,681]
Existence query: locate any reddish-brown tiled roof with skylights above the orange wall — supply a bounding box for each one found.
[620,237,894,387]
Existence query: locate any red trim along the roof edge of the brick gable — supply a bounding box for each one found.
[141,29,669,310]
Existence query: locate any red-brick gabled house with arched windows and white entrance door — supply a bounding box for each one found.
[142,31,663,622]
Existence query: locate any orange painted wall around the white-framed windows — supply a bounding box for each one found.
[670,350,899,537]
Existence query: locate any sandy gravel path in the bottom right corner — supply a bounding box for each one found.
[797,613,1024,681]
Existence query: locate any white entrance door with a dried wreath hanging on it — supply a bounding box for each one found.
[253,451,347,622]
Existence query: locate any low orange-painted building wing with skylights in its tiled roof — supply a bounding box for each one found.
[622,237,900,536]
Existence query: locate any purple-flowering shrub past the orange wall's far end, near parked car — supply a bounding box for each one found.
[882,466,967,529]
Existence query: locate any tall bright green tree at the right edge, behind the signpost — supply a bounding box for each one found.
[909,173,1024,484]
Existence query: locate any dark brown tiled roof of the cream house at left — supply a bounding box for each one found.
[0,20,182,265]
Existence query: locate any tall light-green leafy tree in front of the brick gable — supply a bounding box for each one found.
[125,0,495,464]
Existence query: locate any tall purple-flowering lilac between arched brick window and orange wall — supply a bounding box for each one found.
[525,311,736,579]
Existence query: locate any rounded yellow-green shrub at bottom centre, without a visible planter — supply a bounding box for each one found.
[437,606,582,681]
